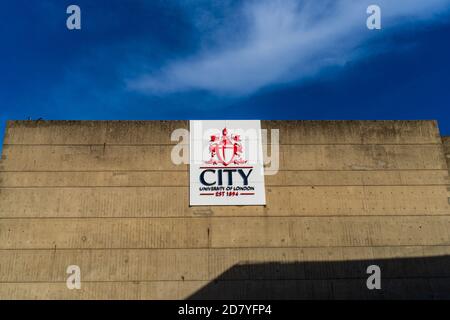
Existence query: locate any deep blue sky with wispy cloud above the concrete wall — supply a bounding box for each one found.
[0,0,450,146]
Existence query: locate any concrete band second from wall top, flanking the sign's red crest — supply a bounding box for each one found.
[0,144,447,171]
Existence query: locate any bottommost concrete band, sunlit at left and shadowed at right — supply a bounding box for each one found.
[0,278,450,300]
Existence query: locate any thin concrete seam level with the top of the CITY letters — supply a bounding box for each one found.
[0,169,448,174]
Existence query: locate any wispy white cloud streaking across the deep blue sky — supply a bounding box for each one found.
[128,0,450,95]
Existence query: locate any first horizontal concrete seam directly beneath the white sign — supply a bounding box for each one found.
[0,214,450,221]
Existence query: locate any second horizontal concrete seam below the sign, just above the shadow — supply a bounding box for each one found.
[0,244,449,251]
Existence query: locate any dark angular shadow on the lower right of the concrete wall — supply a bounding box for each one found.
[187,256,450,299]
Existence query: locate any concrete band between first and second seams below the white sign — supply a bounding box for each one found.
[0,216,450,249]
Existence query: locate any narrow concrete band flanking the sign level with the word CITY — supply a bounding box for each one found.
[0,169,448,188]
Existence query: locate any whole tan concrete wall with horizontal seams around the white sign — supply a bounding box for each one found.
[0,121,450,299]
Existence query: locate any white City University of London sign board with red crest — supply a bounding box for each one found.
[189,120,266,206]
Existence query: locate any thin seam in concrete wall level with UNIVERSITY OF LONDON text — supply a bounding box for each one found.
[0,183,448,189]
